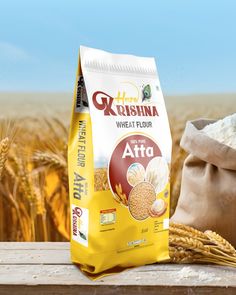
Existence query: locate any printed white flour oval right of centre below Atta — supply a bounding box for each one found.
[145,157,169,193]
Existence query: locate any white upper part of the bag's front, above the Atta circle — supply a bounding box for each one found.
[80,46,172,168]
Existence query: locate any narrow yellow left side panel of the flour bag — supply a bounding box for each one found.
[68,57,94,264]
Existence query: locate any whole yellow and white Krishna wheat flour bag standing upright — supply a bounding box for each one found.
[68,47,171,276]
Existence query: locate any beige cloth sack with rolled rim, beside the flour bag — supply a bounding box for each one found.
[172,119,236,246]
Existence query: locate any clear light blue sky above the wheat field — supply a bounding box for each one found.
[0,0,236,94]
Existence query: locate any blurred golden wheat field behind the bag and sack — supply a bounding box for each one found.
[0,93,236,241]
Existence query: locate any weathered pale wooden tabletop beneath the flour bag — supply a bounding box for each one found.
[0,243,236,295]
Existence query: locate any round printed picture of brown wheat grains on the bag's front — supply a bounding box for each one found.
[128,181,156,220]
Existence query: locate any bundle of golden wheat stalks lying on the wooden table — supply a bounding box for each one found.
[169,223,236,267]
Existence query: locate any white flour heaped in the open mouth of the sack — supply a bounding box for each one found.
[202,113,236,149]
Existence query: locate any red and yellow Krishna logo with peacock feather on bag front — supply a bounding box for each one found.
[92,84,159,116]
